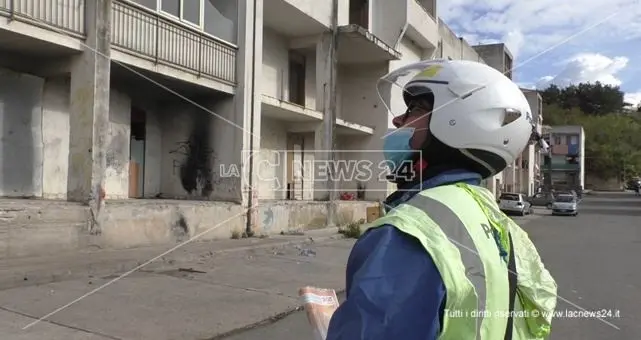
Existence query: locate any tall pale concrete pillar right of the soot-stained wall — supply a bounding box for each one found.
[236,0,263,233]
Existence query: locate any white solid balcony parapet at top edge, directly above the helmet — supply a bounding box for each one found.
[405,0,439,50]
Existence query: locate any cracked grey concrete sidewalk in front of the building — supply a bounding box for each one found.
[0,229,353,340]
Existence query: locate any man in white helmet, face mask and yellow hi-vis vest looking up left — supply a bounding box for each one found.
[327,60,556,340]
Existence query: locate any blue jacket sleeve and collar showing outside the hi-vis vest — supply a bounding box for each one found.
[327,171,481,340]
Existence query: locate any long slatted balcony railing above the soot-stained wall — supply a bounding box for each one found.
[111,0,237,84]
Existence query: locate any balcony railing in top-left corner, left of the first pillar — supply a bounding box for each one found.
[0,0,85,37]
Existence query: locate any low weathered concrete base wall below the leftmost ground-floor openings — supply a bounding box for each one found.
[0,199,245,259]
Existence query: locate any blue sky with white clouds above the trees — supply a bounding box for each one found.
[437,0,641,105]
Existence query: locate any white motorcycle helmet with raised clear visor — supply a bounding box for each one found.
[377,59,547,177]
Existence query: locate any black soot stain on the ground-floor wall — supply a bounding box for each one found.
[170,112,214,198]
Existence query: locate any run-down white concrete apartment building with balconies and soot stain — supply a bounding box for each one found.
[0,0,544,258]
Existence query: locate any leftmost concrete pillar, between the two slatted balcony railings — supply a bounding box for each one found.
[67,0,111,231]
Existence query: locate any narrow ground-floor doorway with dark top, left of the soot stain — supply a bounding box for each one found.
[129,107,147,198]
